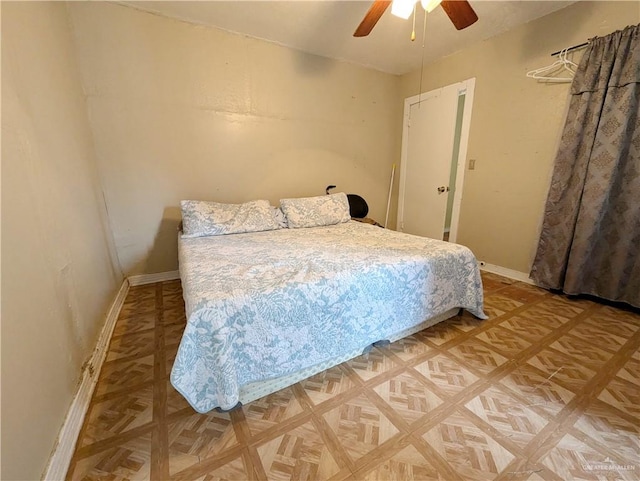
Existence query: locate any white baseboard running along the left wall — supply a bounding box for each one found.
[43,279,129,481]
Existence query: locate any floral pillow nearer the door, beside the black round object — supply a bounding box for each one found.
[280,193,351,229]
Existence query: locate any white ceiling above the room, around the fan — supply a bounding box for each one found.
[120,0,575,75]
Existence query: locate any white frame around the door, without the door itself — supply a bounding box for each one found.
[396,77,476,242]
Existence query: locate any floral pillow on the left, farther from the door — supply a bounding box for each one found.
[180,200,280,237]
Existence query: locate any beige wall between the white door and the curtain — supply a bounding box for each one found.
[401,1,640,273]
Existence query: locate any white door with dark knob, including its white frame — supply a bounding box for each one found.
[397,79,473,242]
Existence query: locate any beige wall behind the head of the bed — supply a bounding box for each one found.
[69,2,402,274]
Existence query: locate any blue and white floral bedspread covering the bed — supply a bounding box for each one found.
[171,221,486,413]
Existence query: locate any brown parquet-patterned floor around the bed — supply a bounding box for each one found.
[67,273,640,481]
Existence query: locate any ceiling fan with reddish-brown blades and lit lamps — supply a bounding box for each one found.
[353,0,478,37]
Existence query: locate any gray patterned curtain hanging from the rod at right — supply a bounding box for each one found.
[531,25,640,307]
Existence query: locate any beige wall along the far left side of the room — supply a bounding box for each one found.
[1,2,121,480]
